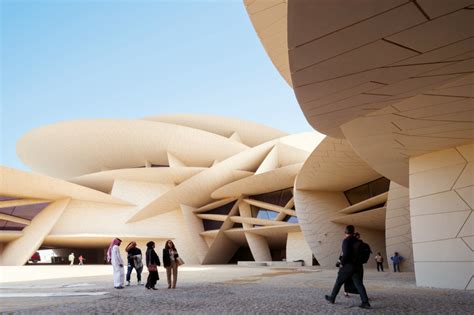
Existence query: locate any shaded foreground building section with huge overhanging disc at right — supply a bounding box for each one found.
[244,0,474,290]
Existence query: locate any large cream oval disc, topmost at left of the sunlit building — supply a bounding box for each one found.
[17,119,248,178]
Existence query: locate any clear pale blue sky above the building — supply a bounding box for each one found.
[0,0,312,170]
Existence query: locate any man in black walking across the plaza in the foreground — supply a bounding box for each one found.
[324,225,370,308]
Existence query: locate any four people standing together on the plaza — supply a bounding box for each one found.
[107,238,184,290]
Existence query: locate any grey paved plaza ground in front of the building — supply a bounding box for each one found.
[0,266,474,314]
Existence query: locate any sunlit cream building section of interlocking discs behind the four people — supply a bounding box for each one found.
[0,115,324,265]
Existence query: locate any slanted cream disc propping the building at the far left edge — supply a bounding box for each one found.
[1,199,70,266]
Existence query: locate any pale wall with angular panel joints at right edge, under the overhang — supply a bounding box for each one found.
[409,144,474,290]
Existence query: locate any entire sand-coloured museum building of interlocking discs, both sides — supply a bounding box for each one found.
[0,0,474,290]
